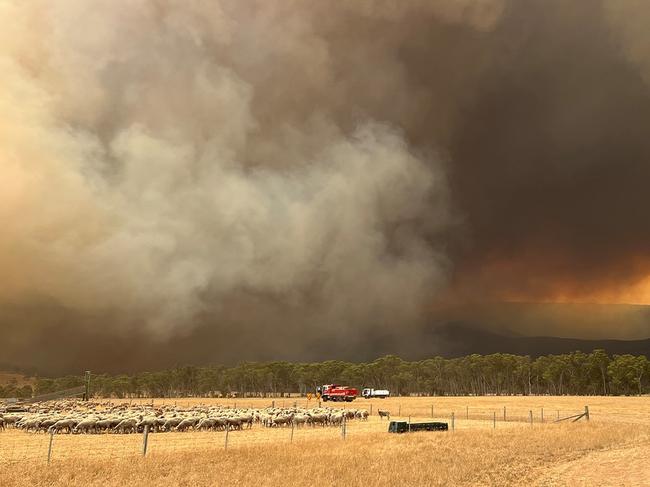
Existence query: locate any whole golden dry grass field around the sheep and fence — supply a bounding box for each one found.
[0,397,650,487]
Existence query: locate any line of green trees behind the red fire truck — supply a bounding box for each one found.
[34,349,650,398]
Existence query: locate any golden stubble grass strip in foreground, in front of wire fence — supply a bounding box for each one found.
[0,423,647,487]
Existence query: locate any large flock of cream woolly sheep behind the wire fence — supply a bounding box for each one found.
[0,400,368,434]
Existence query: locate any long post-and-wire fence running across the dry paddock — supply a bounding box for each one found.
[0,404,589,465]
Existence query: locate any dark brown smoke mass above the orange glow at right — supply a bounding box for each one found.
[452,2,650,304]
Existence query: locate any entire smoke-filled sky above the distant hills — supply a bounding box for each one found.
[0,0,650,370]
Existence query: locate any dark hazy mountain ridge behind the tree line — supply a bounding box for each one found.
[0,321,650,377]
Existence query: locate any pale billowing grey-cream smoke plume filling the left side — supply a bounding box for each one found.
[0,0,480,344]
